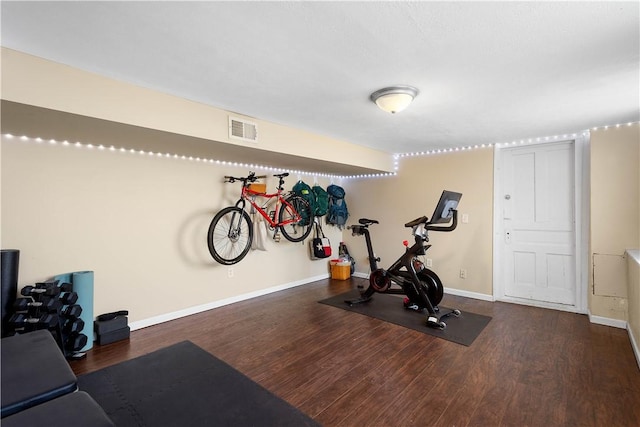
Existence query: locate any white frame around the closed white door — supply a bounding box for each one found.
[493,132,590,314]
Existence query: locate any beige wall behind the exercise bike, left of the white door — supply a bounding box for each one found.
[344,148,493,297]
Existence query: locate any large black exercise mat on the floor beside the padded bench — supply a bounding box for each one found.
[78,341,319,427]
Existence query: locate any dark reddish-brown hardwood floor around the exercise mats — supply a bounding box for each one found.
[71,278,640,427]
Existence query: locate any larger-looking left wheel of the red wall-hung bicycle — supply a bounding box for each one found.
[207,206,253,265]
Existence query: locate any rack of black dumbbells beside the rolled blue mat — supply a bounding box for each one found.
[9,280,88,359]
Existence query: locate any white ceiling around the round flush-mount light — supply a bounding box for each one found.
[1,1,640,153]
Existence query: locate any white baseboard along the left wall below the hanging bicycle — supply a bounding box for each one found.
[129,273,329,331]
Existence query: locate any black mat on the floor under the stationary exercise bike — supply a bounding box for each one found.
[319,290,491,346]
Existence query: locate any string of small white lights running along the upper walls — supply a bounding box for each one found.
[3,122,639,180]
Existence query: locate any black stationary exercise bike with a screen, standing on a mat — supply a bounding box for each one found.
[345,190,462,329]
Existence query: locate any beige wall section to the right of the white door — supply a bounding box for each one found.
[589,123,640,320]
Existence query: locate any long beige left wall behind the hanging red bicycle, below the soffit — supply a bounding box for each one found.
[1,137,340,322]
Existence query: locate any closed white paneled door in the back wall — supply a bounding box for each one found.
[497,141,577,310]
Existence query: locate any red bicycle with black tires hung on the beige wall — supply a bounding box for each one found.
[207,172,314,265]
